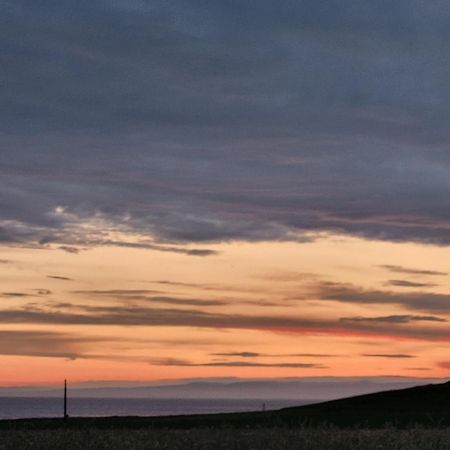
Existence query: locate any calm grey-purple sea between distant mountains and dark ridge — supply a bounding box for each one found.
[0,397,312,419]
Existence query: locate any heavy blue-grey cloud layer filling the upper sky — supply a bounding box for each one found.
[0,0,450,245]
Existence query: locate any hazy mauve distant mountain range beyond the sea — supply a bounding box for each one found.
[0,376,446,401]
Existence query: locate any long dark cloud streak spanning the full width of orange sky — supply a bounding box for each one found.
[0,304,450,342]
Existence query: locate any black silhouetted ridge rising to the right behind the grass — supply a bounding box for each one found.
[0,382,450,429]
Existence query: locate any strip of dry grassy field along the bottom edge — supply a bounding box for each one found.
[0,427,450,450]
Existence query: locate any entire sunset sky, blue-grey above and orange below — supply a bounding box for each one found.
[0,0,450,386]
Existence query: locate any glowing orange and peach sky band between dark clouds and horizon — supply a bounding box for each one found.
[0,236,450,386]
